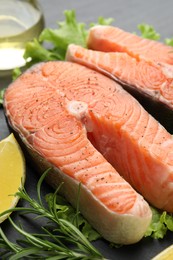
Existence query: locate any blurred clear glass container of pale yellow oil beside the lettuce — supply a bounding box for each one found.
[0,0,44,76]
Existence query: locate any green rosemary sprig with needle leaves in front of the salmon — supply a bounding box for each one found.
[0,171,105,260]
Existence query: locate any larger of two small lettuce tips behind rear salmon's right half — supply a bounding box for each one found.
[137,23,160,41]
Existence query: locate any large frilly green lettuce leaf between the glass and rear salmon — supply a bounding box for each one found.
[24,10,113,66]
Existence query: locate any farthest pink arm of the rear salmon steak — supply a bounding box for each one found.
[88,25,173,65]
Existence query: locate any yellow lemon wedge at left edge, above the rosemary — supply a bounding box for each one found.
[0,134,25,223]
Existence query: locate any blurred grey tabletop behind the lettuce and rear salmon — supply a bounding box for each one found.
[40,0,173,38]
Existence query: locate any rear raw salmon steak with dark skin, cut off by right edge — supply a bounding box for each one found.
[82,26,173,133]
